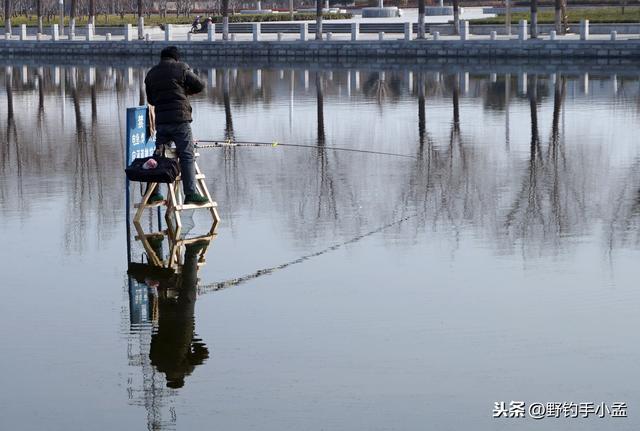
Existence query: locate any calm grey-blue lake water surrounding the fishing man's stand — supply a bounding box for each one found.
[0,59,640,430]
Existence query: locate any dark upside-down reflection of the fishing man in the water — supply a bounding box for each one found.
[149,242,209,388]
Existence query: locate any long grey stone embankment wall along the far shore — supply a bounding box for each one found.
[0,40,640,61]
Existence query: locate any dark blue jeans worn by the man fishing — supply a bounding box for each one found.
[156,123,197,196]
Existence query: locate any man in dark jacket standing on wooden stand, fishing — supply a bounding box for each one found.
[144,46,209,205]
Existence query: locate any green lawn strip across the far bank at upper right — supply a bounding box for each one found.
[470,7,640,24]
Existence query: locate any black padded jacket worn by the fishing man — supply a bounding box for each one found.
[144,58,204,124]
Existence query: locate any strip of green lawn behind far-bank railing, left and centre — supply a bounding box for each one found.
[1,13,351,27]
